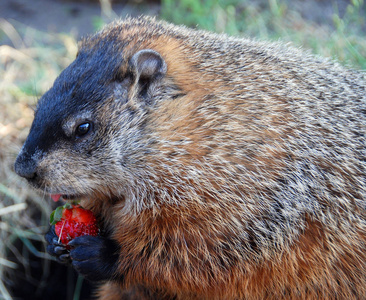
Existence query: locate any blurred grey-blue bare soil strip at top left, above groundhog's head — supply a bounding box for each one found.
[0,0,159,38]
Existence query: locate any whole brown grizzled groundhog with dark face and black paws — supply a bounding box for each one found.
[15,17,366,299]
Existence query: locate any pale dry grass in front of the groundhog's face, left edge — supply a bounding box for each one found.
[0,19,77,299]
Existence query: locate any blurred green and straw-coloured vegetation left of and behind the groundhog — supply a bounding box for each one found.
[0,0,366,300]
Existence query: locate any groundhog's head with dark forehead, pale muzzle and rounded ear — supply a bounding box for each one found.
[15,32,167,202]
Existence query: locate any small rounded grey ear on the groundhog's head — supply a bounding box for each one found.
[130,49,167,83]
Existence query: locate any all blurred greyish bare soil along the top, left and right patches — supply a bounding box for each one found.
[0,0,349,37]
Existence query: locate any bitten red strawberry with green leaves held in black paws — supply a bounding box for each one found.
[50,203,99,245]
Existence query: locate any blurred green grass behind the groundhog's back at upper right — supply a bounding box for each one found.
[161,0,366,69]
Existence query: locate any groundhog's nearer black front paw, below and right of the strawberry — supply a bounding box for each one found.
[69,235,119,281]
